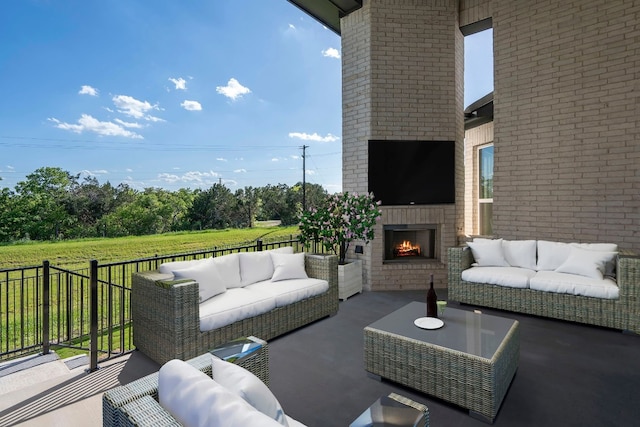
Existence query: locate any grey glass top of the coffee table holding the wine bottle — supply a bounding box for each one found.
[368,302,518,359]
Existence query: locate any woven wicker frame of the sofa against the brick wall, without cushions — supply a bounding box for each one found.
[448,241,640,333]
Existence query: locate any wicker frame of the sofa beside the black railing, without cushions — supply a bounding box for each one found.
[131,254,338,364]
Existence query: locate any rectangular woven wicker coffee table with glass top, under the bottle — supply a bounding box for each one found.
[364,302,520,423]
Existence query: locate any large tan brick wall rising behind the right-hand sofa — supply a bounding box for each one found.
[493,0,640,251]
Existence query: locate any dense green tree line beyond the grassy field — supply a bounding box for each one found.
[0,167,327,243]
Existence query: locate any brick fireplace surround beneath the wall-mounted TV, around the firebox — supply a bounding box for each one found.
[353,204,456,291]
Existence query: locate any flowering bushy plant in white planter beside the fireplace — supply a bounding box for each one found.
[299,191,381,299]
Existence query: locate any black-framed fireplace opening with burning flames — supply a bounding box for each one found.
[383,224,438,262]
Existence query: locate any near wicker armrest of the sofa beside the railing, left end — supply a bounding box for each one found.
[131,271,200,364]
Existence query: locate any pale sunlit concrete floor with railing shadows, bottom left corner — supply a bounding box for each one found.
[0,351,159,427]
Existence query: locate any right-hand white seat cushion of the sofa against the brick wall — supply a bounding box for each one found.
[529,271,619,299]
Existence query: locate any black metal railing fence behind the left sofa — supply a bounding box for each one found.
[0,236,303,371]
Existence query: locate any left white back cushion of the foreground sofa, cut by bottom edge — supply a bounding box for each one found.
[158,359,281,427]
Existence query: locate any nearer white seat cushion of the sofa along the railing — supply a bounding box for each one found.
[200,288,276,332]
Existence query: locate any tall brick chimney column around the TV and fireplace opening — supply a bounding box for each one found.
[341,0,464,290]
